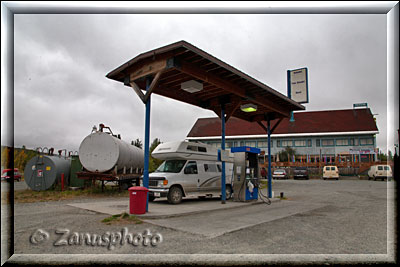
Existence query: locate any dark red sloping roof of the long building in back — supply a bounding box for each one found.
[187,108,378,137]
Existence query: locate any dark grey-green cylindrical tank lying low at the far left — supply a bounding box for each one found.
[24,155,71,191]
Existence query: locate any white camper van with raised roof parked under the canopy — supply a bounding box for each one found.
[149,141,233,204]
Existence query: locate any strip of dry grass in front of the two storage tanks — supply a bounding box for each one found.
[14,186,129,203]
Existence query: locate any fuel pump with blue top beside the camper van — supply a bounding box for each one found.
[231,146,260,201]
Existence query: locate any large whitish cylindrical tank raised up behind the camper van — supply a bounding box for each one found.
[79,124,144,172]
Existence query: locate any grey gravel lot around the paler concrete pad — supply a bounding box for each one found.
[2,179,395,264]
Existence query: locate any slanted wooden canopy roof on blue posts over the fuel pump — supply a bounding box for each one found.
[106,41,305,122]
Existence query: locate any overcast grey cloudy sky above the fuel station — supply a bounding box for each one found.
[7,4,393,155]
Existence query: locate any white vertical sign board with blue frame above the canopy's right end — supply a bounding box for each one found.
[287,68,308,104]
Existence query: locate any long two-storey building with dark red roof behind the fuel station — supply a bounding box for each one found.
[187,108,379,163]
